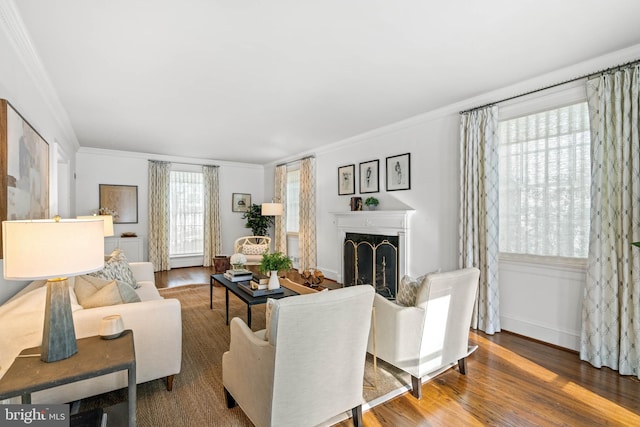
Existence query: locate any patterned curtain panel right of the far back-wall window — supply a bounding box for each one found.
[202,166,222,267]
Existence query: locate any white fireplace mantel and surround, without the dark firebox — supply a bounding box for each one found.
[331,209,415,283]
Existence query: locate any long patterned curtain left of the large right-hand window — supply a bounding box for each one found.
[459,107,500,334]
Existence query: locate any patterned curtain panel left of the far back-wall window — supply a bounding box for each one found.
[149,160,171,271]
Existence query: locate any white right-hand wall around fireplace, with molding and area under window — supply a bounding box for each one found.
[265,45,640,350]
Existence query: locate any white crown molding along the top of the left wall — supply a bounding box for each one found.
[0,0,80,151]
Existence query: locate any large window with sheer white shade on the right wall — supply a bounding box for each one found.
[499,102,590,258]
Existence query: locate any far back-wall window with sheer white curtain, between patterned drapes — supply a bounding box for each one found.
[169,171,204,256]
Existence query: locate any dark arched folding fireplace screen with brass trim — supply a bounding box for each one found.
[343,233,398,299]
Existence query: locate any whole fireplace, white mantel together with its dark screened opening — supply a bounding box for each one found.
[333,210,413,298]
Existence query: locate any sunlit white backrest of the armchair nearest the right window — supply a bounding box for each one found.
[416,268,480,377]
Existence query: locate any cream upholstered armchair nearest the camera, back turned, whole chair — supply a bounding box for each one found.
[222,286,374,427]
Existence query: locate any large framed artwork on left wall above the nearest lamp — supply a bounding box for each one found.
[0,99,49,257]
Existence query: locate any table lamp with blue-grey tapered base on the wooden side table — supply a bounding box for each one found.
[2,217,104,362]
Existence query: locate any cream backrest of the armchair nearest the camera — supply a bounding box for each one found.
[269,286,375,425]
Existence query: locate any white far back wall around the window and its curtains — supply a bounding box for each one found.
[75,148,265,259]
